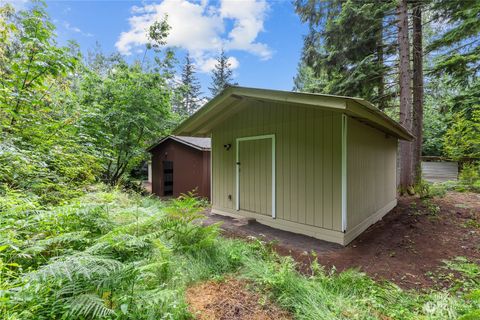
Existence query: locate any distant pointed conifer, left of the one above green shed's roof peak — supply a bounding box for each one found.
[175,53,201,115]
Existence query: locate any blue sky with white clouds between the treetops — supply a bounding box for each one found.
[29,0,307,94]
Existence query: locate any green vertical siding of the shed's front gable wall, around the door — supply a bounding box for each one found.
[212,102,341,231]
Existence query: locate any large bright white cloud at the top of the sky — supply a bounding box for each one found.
[115,0,271,72]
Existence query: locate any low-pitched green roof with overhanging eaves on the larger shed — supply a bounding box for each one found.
[174,86,414,141]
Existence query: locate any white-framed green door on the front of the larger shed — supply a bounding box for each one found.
[238,139,272,216]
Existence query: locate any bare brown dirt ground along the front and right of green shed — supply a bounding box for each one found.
[207,192,480,289]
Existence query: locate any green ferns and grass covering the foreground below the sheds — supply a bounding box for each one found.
[0,186,480,320]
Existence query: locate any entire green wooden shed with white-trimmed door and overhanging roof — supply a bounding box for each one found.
[175,87,413,245]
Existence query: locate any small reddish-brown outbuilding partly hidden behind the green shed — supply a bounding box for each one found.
[147,136,210,198]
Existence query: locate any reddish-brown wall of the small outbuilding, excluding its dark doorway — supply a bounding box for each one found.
[151,139,210,198]
